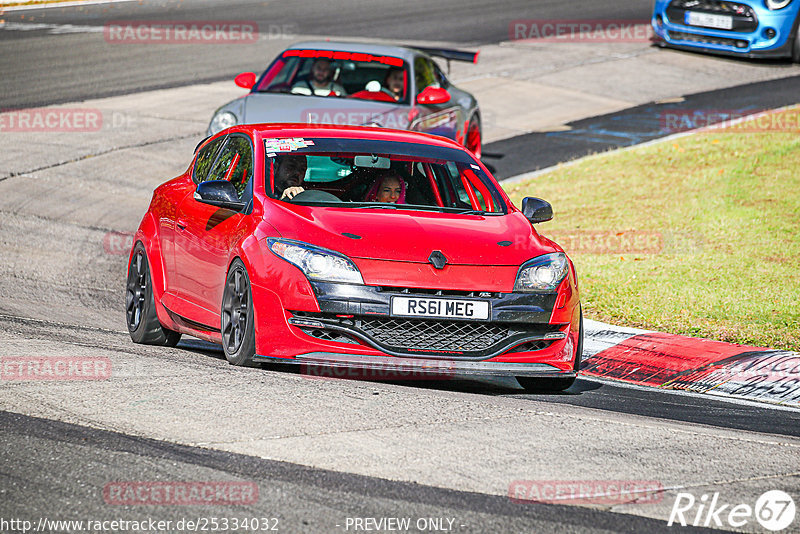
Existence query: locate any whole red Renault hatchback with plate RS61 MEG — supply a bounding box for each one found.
[126,124,583,391]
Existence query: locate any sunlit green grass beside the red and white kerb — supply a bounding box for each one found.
[509,110,800,350]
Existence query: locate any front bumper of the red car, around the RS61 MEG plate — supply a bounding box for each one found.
[247,274,582,377]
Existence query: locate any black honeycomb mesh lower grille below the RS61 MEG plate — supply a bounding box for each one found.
[357,318,509,352]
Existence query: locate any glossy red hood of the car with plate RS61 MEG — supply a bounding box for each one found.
[271,204,556,266]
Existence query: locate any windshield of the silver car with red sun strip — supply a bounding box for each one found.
[256,50,409,104]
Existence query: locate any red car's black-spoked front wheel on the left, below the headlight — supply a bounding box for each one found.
[221,258,258,367]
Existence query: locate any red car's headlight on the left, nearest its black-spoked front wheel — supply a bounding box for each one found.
[267,238,364,284]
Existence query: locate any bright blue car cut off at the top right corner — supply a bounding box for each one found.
[652,0,800,62]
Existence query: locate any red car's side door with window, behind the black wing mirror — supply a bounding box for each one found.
[175,134,253,330]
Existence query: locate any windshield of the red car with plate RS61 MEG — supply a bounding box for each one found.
[264,138,507,214]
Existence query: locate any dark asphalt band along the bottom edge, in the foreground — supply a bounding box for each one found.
[0,412,720,533]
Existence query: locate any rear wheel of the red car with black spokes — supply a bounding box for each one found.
[125,241,181,347]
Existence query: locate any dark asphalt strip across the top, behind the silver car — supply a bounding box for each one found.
[0,0,651,108]
